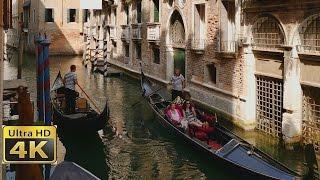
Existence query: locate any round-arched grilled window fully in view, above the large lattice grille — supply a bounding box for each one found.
[252,16,284,49]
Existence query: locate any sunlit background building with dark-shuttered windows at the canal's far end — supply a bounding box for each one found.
[8,0,85,55]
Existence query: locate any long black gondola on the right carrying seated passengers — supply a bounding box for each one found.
[141,71,301,179]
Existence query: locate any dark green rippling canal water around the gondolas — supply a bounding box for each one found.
[4,55,303,179]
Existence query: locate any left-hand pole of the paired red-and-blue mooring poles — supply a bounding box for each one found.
[36,34,44,121]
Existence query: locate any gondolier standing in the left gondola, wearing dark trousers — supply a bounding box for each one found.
[63,65,78,114]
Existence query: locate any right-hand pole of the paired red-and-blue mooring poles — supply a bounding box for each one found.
[41,35,51,125]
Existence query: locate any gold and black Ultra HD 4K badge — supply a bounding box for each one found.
[3,126,56,164]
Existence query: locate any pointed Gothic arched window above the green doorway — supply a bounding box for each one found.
[170,11,185,46]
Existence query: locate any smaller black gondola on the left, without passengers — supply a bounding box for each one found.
[50,72,109,135]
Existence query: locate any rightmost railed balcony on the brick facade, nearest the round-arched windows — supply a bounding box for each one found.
[216,41,238,58]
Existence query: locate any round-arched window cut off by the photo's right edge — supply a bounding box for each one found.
[299,15,320,53]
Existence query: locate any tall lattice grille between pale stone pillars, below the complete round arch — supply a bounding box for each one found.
[256,76,283,137]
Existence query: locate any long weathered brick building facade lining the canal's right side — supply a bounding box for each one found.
[84,0,320,152]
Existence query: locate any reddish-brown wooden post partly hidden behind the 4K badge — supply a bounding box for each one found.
[16,87,43,180]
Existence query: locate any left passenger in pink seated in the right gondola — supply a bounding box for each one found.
[166,103,188,129]
